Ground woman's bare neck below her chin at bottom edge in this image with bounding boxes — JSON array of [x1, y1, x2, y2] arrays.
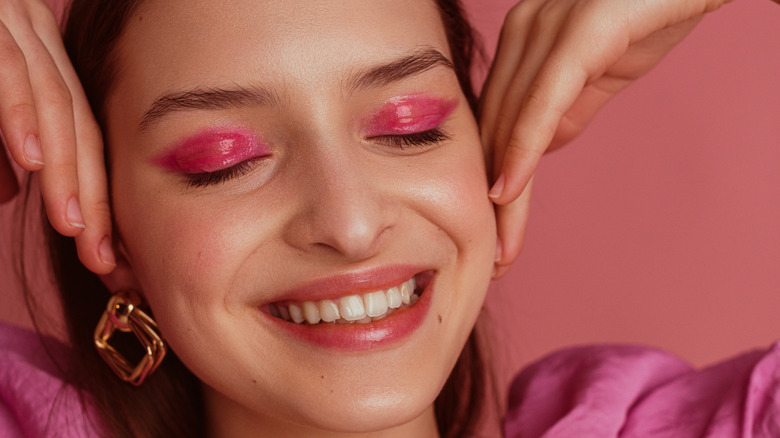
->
[[204, 385, 439, 438]]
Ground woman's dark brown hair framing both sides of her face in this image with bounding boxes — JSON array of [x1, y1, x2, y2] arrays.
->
[[30, 0, 492, 438]]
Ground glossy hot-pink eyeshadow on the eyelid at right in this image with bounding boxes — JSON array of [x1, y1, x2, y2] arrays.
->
[[367, 94, 458, 137]]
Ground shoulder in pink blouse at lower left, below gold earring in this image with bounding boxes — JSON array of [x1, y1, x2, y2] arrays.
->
[[0, 323, 104, 438]]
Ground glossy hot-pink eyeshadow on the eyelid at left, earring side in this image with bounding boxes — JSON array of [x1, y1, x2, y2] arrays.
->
[[154, 129, 269, 174]]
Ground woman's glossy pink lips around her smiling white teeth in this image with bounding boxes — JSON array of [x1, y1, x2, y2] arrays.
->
[[260, 267, 435, 351]]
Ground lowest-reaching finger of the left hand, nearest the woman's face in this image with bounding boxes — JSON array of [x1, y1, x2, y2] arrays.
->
[[32, 9, 116, 274]]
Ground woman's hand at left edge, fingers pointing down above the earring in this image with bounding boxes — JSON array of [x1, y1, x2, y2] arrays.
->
[[0, 0, 115, 274]]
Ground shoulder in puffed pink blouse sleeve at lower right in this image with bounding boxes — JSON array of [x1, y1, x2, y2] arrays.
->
[[504, 344, 780, 438]]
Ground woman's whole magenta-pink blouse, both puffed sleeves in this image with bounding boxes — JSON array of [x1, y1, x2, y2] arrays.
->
[[0, 323, 780, 438]]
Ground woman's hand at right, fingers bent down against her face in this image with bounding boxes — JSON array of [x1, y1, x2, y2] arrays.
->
[[480, 0, 729, 278]]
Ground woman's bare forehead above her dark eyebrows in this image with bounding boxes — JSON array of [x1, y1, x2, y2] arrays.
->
[[112, 0, 449, 114]]
